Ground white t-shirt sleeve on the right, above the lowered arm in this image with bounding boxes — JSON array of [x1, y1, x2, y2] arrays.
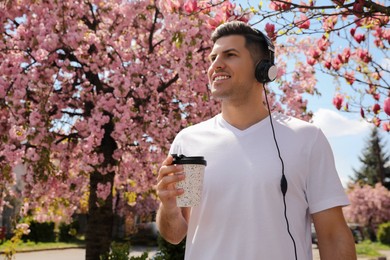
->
[[307, 129, 349, 214]]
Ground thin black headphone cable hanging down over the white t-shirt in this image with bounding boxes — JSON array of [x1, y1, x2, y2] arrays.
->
[[263, 83, 298, 260]]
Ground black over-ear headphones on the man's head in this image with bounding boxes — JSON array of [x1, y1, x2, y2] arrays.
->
[[253, 28, 278, 83]]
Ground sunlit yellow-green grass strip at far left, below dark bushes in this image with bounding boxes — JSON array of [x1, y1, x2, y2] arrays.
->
[[0, 241, 85, 252]]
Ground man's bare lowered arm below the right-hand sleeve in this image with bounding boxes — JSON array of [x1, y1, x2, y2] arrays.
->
[[312, 207, 357, 260]]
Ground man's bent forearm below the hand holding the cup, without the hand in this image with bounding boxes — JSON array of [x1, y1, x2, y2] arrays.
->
[[156, 204, 188, 244]]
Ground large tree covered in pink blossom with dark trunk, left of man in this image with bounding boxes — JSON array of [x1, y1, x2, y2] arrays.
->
[[0, 0, 253, 259]]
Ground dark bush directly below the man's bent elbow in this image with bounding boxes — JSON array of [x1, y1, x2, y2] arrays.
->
[[154, 235, 186, 260]]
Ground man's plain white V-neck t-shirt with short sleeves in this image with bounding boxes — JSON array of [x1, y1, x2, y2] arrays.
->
[[170, 113, 348, 260]]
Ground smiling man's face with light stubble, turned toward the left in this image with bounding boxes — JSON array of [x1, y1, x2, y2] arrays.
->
[[208, 35, 257, 100]]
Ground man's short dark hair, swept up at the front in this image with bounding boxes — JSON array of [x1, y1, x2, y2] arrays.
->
[[211, 21, 274, 64]]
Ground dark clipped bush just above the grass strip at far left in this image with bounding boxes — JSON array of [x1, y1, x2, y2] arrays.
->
[[22, 221, 56, 243]]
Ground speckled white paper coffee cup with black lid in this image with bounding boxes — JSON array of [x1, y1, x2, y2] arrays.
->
[[172, 154, 207, 207]]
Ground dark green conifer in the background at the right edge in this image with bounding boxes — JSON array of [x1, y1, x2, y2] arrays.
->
[[352, 128, 390, 189]]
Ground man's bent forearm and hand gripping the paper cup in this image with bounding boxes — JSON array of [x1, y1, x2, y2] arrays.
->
[[156, 156, 190, 244]]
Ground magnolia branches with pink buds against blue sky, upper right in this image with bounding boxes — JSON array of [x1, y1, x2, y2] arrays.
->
[[245, 0, 390, 131]]
